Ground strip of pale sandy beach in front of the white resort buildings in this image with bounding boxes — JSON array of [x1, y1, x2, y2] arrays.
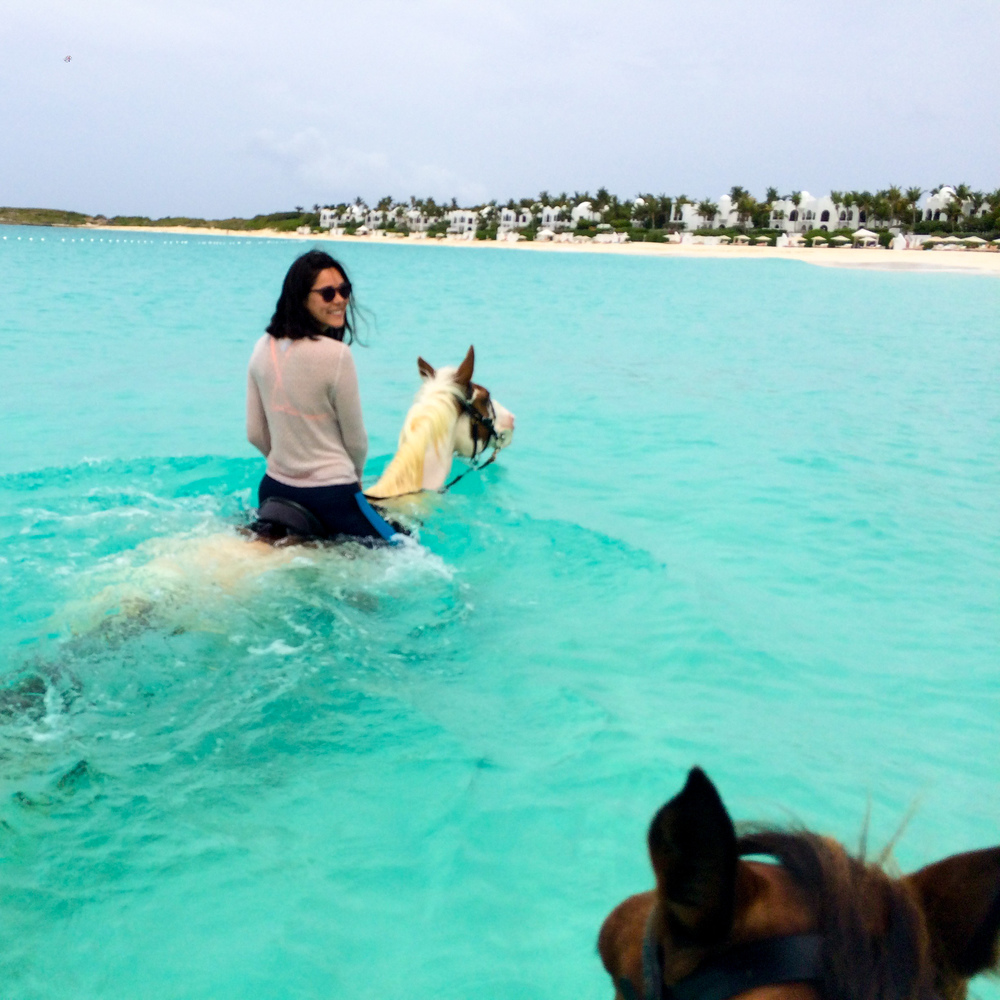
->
[[23, 225, 1000, 277]]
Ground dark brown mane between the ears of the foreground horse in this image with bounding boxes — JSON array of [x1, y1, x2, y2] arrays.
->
[[737, 828, 938, 1000]]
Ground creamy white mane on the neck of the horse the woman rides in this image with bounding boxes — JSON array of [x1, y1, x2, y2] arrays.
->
[[365, 367, 462, 498]]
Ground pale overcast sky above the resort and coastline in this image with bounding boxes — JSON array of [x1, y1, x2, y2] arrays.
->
[[0, 0, 1000, 217]]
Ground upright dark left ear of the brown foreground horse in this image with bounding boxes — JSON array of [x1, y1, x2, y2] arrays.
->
[[649, 767, 738, 947]]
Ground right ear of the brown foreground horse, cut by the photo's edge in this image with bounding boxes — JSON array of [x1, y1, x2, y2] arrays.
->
[[906, 847, 1000, 978]]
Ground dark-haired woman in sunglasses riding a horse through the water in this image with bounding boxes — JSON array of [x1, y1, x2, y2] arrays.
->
[[247, 250, 396, 540]]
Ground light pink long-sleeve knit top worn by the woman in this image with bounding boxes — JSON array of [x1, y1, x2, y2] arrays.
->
[[247, 333, 368, 486]]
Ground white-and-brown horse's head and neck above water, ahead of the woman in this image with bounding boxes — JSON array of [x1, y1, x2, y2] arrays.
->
[[365, 347, 514, 503]]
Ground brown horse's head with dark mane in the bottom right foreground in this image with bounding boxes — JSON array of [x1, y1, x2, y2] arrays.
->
[[598, 768, 1000, 1000]]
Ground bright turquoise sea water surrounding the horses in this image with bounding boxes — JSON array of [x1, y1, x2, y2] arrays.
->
[[0, 227, 1000, 1000]]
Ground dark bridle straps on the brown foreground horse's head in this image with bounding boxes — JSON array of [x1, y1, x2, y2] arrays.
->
[[618, 907, 823, 1000]]
